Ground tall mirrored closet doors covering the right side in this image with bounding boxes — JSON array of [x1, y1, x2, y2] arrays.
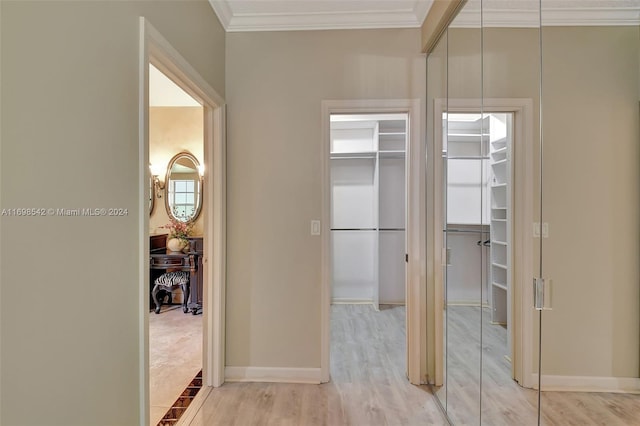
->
[[427, 0, 640, 424]]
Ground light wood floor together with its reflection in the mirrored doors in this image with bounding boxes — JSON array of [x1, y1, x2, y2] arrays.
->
[[181, 305, 640, 426]]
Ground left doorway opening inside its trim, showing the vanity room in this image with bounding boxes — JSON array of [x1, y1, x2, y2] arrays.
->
[[149, 64, 202, 425]]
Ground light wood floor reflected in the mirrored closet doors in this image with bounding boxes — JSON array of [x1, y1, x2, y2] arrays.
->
[[436, 306, 640, 426]]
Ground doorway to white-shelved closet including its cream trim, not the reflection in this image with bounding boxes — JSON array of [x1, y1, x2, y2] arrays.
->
[[321, 99, 426, 384]]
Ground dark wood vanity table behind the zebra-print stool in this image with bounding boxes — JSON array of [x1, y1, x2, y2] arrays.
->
[[149, 234, 203, 315]]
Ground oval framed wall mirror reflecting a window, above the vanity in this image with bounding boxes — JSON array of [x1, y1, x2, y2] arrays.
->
[[164, 152, 202, 222]]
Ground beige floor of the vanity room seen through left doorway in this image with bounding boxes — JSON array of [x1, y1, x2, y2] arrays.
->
[[149, 306, 202, 426]]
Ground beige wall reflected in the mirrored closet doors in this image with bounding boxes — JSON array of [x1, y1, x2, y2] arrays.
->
[[428, 27, 640, 377]]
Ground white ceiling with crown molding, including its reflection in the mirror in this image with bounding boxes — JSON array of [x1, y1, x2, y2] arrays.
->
[[209, 0, 640, 32]]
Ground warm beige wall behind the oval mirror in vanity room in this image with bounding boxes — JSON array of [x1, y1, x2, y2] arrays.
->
[[149, 107, 207, 235]]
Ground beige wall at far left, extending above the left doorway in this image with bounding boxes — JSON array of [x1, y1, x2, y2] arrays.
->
[[0, 0, 225, 426]]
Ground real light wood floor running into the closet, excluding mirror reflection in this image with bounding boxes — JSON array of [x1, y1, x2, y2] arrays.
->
[[185, 305, 447, 426]]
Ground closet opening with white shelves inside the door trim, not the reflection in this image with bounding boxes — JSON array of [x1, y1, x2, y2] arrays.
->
[[329, 113, 408, 382]]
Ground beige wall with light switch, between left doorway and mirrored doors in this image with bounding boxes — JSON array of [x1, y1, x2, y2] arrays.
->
[[226, 29, 425, 368]]
